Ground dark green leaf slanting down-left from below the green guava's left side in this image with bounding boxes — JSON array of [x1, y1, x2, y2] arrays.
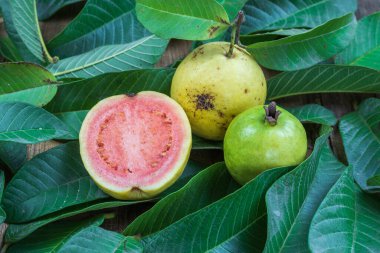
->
[[123, 163, 238, 236]]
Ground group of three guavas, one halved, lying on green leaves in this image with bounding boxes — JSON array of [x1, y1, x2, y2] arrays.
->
[[79, 37, 307, 200]]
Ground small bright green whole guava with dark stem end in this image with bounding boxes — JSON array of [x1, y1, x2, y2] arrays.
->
[[224, 102, 307, 185]]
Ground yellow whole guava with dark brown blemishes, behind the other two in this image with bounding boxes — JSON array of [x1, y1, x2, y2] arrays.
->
[[171, 42, 267, 140]]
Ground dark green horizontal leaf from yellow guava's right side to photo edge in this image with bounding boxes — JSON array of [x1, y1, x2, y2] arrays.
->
[[268, 65, 380, 100]]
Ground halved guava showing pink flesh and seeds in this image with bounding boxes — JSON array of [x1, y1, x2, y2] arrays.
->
[[79, 91, 192, 200]]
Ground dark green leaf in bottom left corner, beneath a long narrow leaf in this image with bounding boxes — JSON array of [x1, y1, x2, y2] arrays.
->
[[7, 216, 104, 253]]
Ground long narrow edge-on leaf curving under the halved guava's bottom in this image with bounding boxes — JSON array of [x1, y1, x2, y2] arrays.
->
[[5, 160, 204, 243]]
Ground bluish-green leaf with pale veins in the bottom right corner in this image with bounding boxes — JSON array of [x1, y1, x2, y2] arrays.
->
[[309, 168, 380, 252]]
